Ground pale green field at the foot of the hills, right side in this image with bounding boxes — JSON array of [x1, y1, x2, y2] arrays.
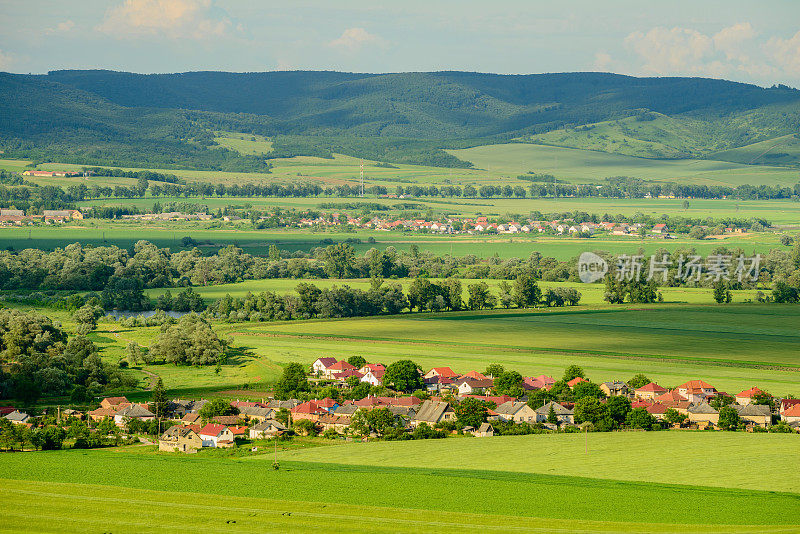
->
[[447, 143, 798, 186]]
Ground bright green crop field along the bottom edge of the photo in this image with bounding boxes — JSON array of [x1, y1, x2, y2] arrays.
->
[[0, 448, 800, 532]]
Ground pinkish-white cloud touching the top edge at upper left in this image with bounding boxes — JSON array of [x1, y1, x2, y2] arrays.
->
[[97, 0, 233, 39]]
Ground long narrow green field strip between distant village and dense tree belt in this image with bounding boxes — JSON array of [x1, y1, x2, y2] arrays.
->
[[0, 221, 789, 260]]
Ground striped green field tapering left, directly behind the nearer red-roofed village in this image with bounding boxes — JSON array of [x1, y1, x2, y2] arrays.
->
[[220, 304, 800, 395]]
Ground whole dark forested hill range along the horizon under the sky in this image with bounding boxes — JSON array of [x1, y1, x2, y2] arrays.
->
[[0, 70, 800, 170]]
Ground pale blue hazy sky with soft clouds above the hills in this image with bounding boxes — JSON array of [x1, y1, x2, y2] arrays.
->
[[0, 0, 800, 87]]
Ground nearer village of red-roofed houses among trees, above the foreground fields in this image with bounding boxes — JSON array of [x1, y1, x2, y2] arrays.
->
[[0, 357, 800, 453]]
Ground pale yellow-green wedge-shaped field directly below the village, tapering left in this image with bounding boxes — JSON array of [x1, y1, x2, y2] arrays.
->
[[278, 430, 800, 494]]
